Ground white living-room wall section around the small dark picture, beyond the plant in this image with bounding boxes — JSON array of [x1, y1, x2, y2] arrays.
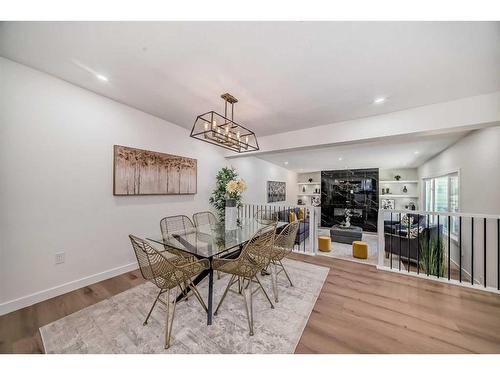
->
[[228, 156, 297, 204]]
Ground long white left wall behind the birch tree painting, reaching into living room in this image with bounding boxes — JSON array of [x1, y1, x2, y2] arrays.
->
[[0, 58, 296, 315]]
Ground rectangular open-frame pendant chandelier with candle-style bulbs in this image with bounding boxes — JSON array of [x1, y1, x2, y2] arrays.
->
[[191, 93, 259, 152]]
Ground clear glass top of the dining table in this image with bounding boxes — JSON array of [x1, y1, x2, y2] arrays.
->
[[146, 219, 287, 258]]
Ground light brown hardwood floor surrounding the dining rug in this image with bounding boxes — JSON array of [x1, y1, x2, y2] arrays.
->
[[0, 254, 500, 353]]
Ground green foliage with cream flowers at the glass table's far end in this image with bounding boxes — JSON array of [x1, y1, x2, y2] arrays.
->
[[209, 167, 246, 221]]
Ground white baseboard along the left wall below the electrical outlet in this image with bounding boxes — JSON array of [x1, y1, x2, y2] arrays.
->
[[0, 262, 137, 316]]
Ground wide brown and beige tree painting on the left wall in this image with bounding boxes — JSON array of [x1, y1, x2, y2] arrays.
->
[[113, 145, 197, 195]]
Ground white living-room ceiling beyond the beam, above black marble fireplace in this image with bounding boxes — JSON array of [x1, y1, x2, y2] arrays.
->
[[258, 132, 468, 173]]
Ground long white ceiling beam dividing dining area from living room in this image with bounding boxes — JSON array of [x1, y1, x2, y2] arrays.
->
[[248, 91, 500, 154]]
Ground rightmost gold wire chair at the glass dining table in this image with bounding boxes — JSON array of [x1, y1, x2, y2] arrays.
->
[[270, 220, 300, 302]]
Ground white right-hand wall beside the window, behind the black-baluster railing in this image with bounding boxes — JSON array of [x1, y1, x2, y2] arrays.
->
[[418, 126, 500, 287]]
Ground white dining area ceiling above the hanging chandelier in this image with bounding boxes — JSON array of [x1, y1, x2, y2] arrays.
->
[[0, 22, 500, 136]]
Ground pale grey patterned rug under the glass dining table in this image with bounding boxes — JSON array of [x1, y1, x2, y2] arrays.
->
[[40, 259, 329, 353]]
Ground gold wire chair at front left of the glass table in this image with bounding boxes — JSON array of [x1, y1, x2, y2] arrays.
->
[[129, 235, 210, 349]]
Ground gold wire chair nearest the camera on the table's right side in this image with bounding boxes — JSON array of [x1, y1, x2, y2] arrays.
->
[[212, 223, 276, 336]]
